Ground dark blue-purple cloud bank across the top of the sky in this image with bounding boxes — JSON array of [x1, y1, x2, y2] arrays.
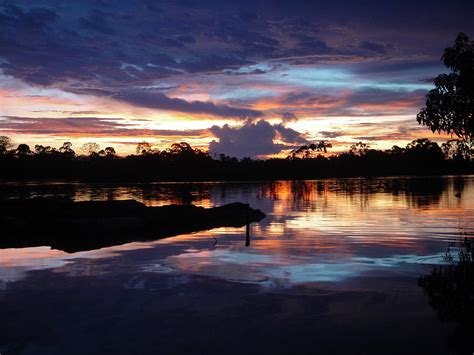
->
[[0, 0, 473, 84]]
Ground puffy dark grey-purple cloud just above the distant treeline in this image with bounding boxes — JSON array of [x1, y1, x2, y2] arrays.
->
[[209, 120, 307, 158]]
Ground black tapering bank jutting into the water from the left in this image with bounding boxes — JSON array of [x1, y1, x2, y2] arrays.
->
[[0, 198, 265, 252]]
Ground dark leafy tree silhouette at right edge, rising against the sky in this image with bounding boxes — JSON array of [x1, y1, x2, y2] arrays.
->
[[416, 33, 474, 142]]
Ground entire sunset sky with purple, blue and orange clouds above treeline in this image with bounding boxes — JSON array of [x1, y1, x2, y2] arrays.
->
[[0, 0, 474, 158]]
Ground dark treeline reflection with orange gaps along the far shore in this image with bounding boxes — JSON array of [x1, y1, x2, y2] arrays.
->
[[0, 176, 462, 210]]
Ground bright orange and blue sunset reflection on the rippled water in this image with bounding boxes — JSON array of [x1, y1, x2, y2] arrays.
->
[[0, 177, 474, 287]]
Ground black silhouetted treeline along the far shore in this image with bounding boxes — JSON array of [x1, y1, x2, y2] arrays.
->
[[0, 137, 474, 181]]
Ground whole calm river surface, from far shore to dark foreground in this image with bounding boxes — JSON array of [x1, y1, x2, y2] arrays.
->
[[0, 177, 474, 355]]
